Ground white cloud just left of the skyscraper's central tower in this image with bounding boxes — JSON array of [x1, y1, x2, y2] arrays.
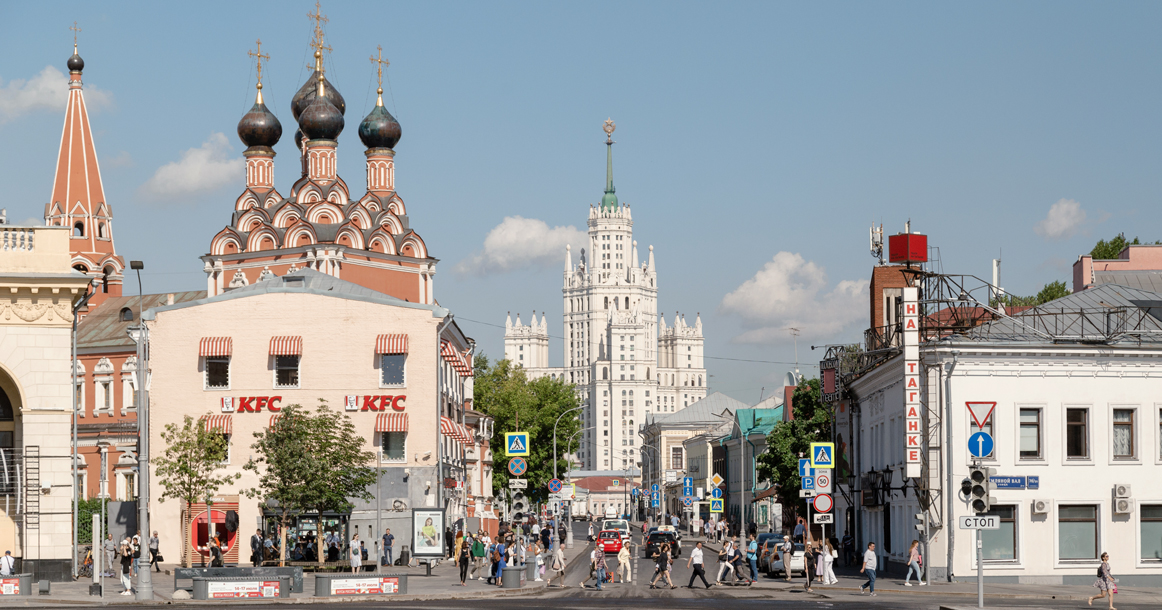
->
[[456, 216, 586, 274]]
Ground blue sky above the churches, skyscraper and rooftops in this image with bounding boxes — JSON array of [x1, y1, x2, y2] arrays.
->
[[0, 1, 1162, 402]]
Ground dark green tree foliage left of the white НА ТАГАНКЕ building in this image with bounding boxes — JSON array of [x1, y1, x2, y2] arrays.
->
[[758, 379, 831, 517]]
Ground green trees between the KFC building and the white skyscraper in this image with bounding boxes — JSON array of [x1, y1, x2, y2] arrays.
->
[[473, 356, 581, 502]]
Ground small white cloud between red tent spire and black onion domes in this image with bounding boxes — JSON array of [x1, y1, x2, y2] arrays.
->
[[141, 132, 246, 201]]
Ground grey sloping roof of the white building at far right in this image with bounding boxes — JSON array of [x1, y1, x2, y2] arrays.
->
[[949, 284, 1162, 345]]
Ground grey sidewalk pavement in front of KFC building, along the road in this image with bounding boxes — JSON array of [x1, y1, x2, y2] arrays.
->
[[5, 540, 588, 607]]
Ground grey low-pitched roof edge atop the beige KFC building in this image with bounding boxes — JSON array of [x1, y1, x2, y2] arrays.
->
[[144, 268, 449, 320]]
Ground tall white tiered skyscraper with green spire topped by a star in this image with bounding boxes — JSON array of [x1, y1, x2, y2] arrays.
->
[[504, 121, 706, 471]]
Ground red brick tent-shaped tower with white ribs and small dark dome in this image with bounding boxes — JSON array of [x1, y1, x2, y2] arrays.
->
[[44, 38, 125, 310]]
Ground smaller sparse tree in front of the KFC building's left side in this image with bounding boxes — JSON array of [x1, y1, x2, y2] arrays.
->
[[153, 415, 242, 565]]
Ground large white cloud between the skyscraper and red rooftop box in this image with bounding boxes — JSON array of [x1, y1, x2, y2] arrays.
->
[[719, 252, 868, 343]]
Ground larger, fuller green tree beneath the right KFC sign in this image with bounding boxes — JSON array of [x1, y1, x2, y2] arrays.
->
[[243, 400, 376, 564]]
